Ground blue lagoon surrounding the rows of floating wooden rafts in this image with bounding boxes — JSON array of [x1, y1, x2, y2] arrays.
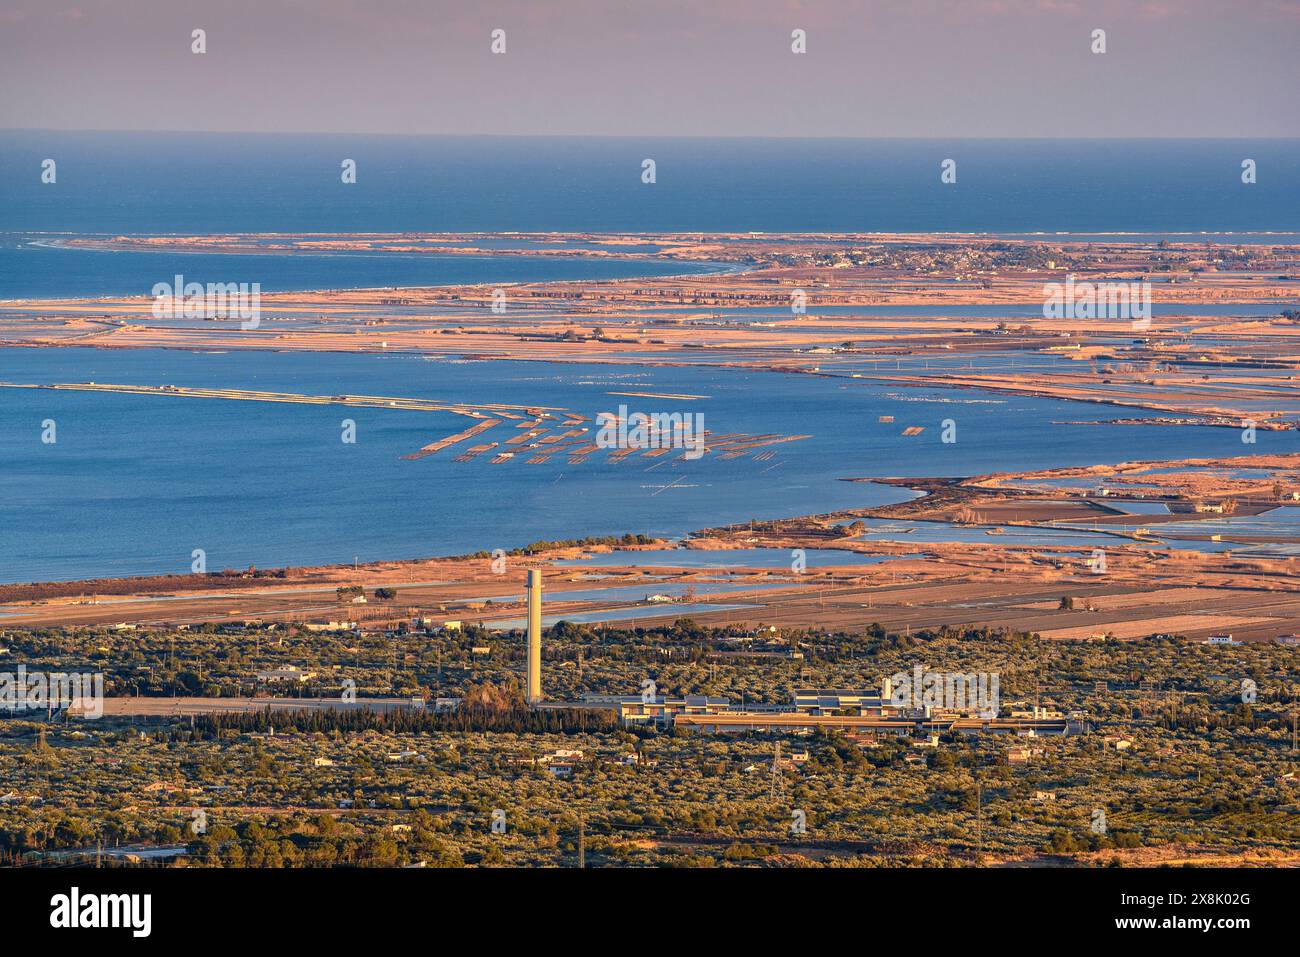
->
[[0, 348, 1297, 581]]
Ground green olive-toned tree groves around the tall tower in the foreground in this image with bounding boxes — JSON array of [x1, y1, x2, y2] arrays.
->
[[0, 619, 1300, 867]]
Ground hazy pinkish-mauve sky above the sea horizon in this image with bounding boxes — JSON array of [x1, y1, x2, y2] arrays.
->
[[0, 0, 1300, 137]]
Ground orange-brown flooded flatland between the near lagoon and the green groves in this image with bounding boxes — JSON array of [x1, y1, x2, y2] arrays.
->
[[10, 452, 1300, 641]]
